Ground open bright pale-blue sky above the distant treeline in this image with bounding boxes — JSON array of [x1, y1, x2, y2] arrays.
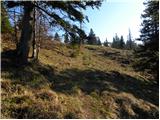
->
[[84, 0, 145, 42]]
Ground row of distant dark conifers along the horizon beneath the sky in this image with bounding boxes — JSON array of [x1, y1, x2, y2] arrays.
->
[[52, 29, 138, 50]]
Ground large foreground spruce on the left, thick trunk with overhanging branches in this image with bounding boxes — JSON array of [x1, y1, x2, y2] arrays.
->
[[5, 1, 102, 65]]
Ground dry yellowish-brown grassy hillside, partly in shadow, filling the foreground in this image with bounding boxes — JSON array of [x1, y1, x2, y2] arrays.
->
[[1, 39, 159, 118]]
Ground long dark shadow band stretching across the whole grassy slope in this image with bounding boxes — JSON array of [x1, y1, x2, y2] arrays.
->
[[1, 49, 159, 105]]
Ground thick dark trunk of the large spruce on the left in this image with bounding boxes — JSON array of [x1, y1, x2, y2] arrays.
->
[[18, 2, 33, 64]]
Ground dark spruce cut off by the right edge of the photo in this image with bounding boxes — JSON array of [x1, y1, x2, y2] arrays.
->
[[135, 1, 159, 81]]
